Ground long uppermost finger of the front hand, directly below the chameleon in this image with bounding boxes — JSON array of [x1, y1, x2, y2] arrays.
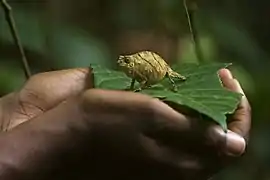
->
[[82, 89, 192, 132]]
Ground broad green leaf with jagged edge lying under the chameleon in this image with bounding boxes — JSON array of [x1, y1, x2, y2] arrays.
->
[[92, 63, 241, 130]]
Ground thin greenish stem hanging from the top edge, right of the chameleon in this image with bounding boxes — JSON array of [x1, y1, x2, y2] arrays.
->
[[183, 0, 203, 62]]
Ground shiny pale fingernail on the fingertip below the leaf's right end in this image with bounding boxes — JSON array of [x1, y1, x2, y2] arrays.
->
[[225, 130, 246, 156]]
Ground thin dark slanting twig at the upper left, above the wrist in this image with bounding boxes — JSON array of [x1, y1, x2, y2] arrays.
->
[[1, 0, 31, 79]]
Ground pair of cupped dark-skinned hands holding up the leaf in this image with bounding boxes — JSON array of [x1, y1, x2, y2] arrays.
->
[[0, 69, 251, 180]]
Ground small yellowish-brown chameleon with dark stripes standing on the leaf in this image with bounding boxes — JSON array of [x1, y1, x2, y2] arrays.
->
[[117, 51, 186, 91]]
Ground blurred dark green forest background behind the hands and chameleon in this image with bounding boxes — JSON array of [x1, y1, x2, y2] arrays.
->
[[0, 0, 270, 180]]
